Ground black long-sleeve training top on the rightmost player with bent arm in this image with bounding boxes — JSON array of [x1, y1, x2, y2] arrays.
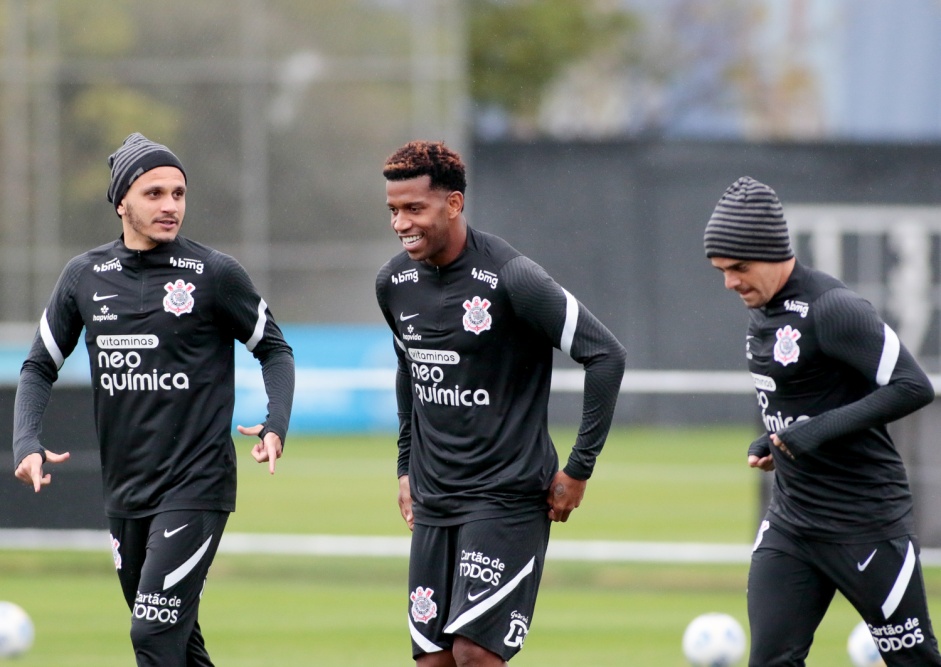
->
[[745, 262, 934, 543]]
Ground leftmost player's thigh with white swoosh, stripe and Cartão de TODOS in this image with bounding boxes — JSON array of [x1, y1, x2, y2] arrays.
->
[[132, 510, 228, 629]]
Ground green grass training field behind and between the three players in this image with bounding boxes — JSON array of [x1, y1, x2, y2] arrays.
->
[[0, 429, 928, 667]]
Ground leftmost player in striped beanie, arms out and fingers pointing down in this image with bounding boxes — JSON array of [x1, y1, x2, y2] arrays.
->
[[13, 133, 294, 667]]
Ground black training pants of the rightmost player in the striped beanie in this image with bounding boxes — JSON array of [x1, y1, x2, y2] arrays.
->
[[748, 517, 941, 667]]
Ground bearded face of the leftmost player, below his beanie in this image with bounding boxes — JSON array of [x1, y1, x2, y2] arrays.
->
[[117, 167, 186, 250]]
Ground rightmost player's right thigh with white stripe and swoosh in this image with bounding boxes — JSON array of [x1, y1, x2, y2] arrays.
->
[[827, 536, 941, 667]]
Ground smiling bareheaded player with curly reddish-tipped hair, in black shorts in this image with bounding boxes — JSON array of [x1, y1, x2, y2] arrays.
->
[[376, 141, 625, 667]]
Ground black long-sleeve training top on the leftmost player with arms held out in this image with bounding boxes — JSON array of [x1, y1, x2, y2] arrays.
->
[[13, 237, 294, 518]]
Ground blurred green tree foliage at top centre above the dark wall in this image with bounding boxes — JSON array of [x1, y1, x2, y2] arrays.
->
[[468, 0, 639, 119]]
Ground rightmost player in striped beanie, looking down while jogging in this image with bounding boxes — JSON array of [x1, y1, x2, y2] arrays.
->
[[705, 177, 941, 667]]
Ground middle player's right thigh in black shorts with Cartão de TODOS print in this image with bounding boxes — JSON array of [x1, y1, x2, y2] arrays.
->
[[445, 511, 551, 660]]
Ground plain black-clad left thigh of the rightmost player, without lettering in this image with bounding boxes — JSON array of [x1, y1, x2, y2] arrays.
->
[[747, 531, 836, 667]]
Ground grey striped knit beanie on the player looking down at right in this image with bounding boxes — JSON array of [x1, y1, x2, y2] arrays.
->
[[704, 176, 794, 262]]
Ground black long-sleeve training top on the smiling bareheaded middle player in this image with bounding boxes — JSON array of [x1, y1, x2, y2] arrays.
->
[[376, 228, 625, 525]]
